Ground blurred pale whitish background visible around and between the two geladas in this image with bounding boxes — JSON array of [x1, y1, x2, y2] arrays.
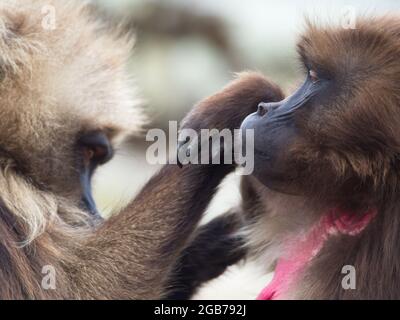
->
[[88, 0, 400, 298]]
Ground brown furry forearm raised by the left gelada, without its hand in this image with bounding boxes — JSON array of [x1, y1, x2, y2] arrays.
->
[[74, 165, 234, 299]]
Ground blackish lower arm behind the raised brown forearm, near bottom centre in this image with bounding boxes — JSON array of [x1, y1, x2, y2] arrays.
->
[[167, 210, 247, 300]]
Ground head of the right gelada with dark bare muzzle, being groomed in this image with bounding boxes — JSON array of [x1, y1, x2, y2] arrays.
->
[[242, 18, 400, 200]]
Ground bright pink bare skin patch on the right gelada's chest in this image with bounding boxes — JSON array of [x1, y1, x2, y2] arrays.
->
[[257, 209, 376, 300]]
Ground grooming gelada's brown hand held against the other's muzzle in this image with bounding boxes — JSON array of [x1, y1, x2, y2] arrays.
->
[[178, 72, 283, 165]]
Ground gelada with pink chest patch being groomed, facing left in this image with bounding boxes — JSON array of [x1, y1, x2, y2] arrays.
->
[[174, 16, 400, 299]]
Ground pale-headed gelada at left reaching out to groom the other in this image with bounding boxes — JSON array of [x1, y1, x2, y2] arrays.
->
[[0, 0, 278, 299]]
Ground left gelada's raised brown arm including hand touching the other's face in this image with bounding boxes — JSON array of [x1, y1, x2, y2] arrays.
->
[[70, 73, 283, 299]]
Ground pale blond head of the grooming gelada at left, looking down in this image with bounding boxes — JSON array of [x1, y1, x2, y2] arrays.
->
[[0, 0, 141, 211]]
